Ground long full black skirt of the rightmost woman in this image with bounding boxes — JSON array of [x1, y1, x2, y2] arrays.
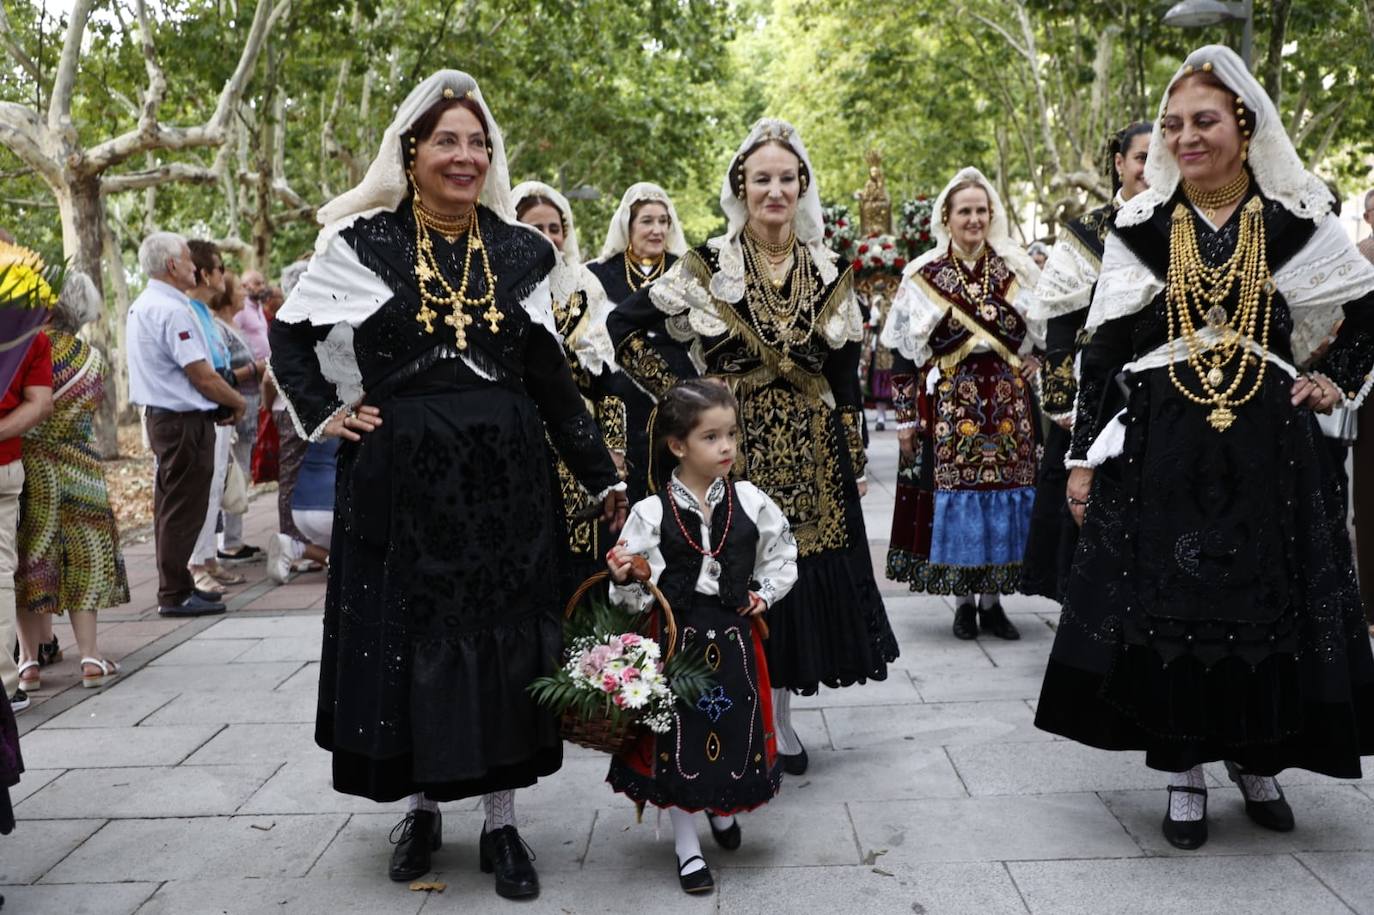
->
[[1036, 367, 1374, 778]]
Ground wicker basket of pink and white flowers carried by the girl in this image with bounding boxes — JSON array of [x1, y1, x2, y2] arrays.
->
[[529, 573, 713, 753]]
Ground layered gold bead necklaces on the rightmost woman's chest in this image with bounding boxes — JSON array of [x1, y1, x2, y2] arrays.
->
[[1165, 196, 1274, 431]]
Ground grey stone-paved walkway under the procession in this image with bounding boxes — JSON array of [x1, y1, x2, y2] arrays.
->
[[0, 431, 1374, 915]]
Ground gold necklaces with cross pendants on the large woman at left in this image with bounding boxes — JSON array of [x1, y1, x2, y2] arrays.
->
[[412, 190, 506, 349]]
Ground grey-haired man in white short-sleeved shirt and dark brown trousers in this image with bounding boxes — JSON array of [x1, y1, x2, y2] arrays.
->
[[126, 232, 246, 617]]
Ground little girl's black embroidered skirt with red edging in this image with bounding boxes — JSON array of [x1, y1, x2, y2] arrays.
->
[[606, 595, 782, 813]]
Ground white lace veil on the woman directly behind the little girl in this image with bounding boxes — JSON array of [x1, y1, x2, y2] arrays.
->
[[709, 118, 840, 302]]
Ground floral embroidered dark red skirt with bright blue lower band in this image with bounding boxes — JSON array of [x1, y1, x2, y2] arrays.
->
[[888, 353, 1036, 595]]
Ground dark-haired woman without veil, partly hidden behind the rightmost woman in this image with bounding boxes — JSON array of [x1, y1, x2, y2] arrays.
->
[[1021, 121, 1151, 600]]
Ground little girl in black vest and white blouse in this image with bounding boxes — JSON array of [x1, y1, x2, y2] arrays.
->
[[606, 378, 797, 893]]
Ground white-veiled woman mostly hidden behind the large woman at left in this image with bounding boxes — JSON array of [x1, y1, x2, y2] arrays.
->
[[511, 181, 627, 598]]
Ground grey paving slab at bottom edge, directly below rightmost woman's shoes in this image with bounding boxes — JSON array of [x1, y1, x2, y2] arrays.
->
[[1007, 855, 1349, 915]]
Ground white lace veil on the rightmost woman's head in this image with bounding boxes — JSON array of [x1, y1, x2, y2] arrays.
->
[[1117, 44, 1331, 227]]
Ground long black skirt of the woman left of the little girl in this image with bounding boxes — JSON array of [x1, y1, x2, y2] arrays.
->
[[315, 376, 562, 801]]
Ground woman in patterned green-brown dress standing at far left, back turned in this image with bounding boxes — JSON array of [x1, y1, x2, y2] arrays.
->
[[15, 273, 129, 694]]
